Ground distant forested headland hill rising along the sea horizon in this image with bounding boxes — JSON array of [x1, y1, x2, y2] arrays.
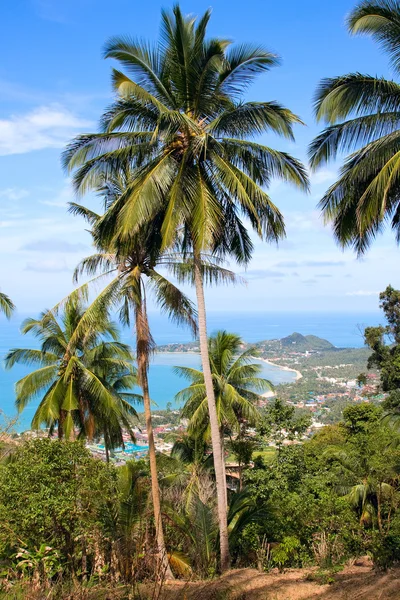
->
[[157, 332, 336, 353]]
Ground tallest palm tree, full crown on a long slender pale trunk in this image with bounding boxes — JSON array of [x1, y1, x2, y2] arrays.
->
[[64, 6, 308, 570]]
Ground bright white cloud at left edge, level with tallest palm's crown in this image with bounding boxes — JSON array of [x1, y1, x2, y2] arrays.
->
[[0, 104, 92, 156]]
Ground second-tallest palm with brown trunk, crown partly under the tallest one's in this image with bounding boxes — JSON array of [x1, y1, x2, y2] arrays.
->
[[64, 168, 202, 578]]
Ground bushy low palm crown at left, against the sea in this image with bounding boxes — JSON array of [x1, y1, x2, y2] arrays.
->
[[5, 300, 141, 458]]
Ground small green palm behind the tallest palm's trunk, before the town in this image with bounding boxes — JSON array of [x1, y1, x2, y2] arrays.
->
[[175, 331, 272, 500]]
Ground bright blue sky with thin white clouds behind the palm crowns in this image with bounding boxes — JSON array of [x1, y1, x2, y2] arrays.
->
[[0, 0, 400, 314]]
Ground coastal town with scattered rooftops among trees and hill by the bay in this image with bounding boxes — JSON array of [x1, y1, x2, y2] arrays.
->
[[75, 333, 386, 468]]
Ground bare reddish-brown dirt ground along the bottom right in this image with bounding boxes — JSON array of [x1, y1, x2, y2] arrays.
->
[[148, 559, 400, 600]]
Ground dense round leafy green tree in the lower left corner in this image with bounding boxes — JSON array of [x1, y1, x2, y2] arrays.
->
[[0, 438, 116, 574]]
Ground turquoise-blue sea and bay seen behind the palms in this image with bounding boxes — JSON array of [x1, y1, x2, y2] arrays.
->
[[0, 311, 382, 431]]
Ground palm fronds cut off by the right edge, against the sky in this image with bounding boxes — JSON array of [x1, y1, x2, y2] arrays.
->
[[310, 0, 400, 254]]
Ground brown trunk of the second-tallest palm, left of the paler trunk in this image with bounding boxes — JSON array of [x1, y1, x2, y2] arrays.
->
[[135, 303, 173, 579]]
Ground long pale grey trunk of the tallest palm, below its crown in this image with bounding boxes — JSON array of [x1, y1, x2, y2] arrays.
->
[[194, 253, 230, 573]]
